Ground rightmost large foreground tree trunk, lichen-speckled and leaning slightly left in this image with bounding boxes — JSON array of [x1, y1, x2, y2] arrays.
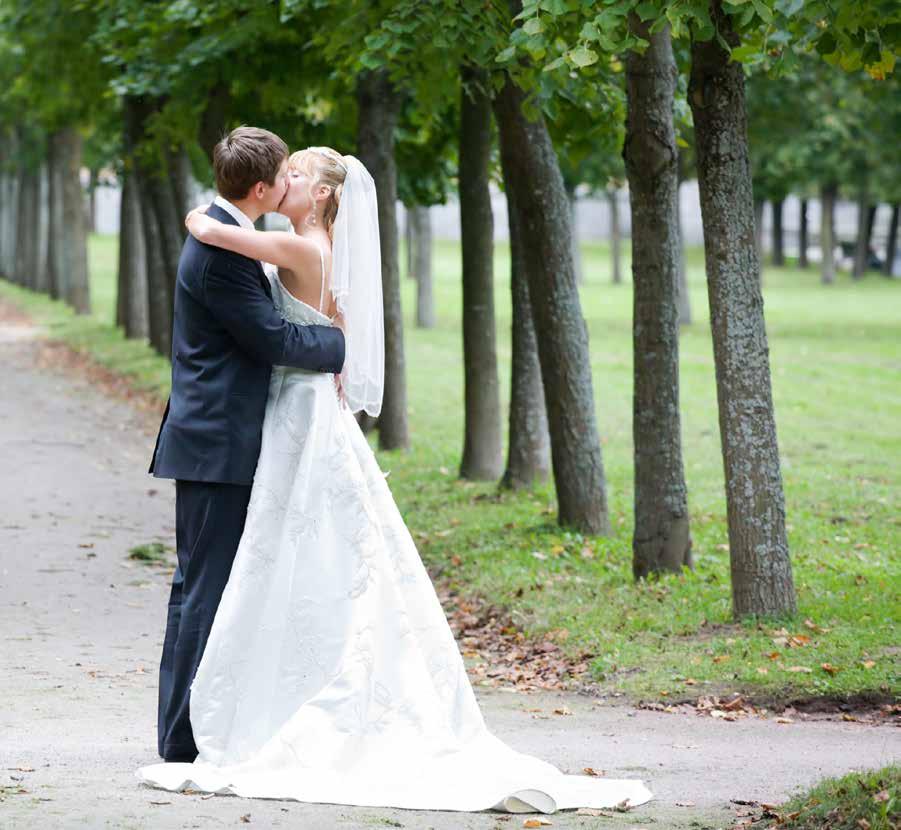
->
[[689, 0, 796, 617]]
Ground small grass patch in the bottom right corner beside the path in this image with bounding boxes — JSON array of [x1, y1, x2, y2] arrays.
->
[[771, 765, 901, 830]]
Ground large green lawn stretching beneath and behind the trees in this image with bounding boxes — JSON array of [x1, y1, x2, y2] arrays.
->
[[0, 237, 901, 699]]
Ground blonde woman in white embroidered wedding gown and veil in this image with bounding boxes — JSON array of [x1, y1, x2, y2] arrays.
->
[[136, 147, 653, 813]]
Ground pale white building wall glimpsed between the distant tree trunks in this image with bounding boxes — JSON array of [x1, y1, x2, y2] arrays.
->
[[96, 181, 901, 274]]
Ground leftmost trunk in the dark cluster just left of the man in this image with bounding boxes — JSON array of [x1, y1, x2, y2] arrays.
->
[[116, 166, 150, 339]]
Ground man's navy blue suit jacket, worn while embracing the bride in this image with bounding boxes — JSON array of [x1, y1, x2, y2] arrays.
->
[[150, 205, 344, 484]]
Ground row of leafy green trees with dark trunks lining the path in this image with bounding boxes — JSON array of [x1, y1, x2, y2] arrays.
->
[[0, 0, 899, 615]]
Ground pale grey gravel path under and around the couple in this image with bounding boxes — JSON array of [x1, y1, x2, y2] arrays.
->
[[0, 307, 901, 830]]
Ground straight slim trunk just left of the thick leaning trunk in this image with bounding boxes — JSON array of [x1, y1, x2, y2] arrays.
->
[[459, 66, 504, 481]]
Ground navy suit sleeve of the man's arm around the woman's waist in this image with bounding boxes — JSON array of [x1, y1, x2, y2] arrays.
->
[[203, 252, 344, 374]]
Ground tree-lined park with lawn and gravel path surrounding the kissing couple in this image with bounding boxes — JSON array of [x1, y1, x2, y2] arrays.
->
[[0, 0, 901, 830]]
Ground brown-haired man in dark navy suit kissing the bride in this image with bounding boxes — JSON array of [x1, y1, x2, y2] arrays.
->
[[150, 127, 344, 761]]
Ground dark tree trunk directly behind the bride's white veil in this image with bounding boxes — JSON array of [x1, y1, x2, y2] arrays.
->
[[357, 70, 410, 450]]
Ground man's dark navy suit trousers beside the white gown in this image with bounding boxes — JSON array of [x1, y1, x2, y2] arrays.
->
[[157, 480, 251, 761]]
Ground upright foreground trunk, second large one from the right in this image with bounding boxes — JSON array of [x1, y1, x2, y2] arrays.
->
[[623, 14, 691, 579]]
